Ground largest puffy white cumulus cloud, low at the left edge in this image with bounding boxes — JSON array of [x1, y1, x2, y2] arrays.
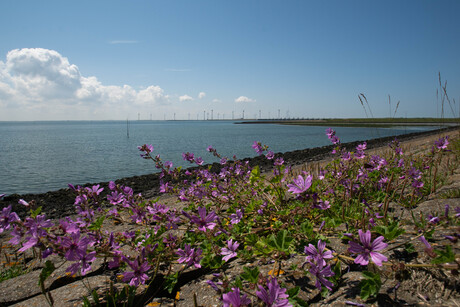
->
[[0, 48, 169, 119]]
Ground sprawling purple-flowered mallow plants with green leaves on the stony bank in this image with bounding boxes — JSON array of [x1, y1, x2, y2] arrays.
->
[[0, 129, 460, 306]]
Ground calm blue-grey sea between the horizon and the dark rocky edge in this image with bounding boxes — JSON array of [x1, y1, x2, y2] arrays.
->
[[0, 121, 433, 194]]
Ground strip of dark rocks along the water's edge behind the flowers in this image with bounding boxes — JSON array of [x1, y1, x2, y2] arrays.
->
[[0, 127, 458, 219]]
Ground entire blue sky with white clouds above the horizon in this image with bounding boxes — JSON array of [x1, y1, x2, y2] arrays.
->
[[0, 0, 460, 121]]
